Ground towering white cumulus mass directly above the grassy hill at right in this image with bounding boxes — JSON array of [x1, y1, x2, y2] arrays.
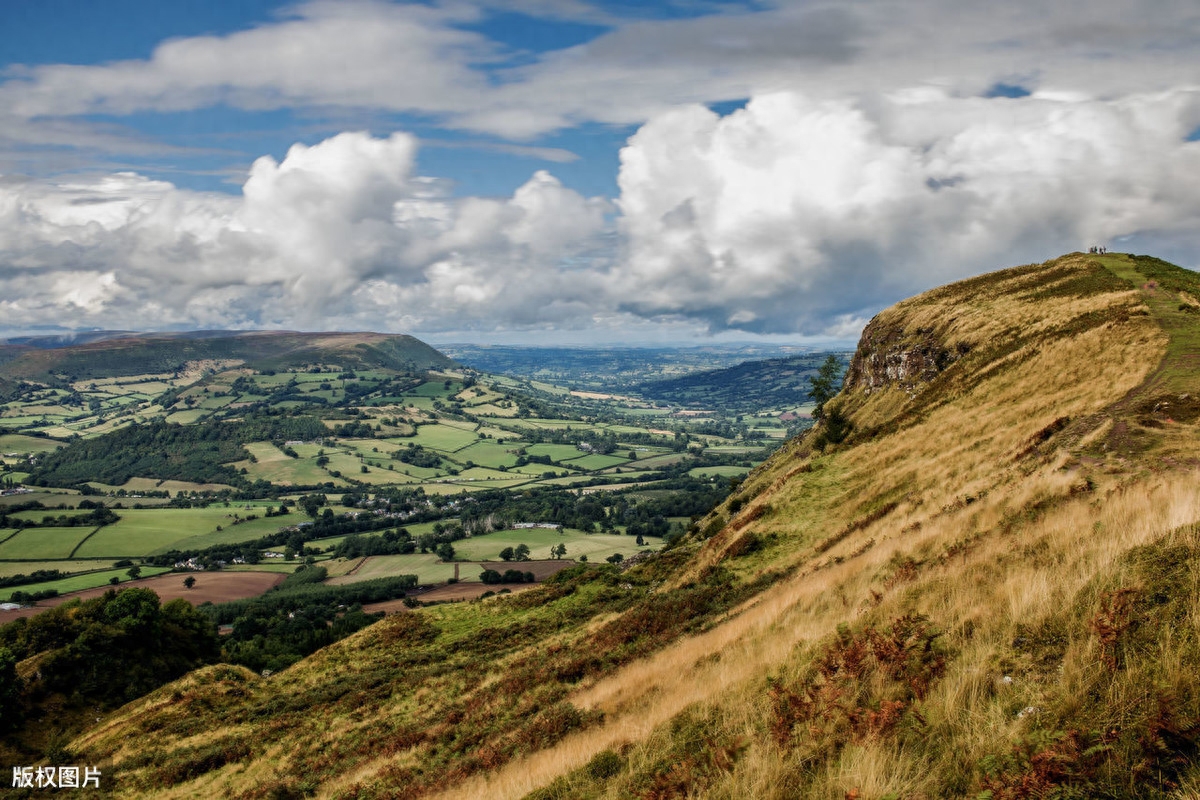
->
[[610, 89, 1200, 335]]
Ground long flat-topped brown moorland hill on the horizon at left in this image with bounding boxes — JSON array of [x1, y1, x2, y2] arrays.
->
[[0, 331, 455, 387]]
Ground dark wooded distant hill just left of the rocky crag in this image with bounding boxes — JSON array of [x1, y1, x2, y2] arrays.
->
[[630, 353, 851, 411]]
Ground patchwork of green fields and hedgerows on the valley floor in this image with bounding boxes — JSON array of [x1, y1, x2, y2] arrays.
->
[[0, 333, 806, 633]]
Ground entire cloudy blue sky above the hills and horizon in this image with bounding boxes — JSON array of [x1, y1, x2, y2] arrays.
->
[[0, 0, 1200, 345]]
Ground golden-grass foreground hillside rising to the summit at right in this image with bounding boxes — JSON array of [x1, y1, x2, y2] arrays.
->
[[68, 254, 1200, 800]]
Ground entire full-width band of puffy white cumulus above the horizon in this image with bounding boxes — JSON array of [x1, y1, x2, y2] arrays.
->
[[0, 86, 1200, 339]]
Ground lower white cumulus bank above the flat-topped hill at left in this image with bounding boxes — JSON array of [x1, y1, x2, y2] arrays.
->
[[0, 133, 610, 330]]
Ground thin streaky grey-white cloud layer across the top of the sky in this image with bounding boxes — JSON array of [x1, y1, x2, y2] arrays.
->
[[0, 0, 1200, 148]]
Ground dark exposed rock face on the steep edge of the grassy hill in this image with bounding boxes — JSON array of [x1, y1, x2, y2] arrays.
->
[[845, 315, 966, 395]]
